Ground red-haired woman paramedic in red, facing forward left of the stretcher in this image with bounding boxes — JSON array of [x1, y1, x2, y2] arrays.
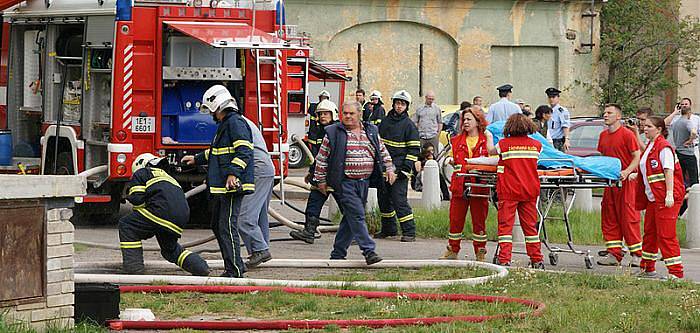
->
[[440, 108, 489, 261]]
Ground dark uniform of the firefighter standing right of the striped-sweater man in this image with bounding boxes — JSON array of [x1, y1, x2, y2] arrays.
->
[[375, 104, 420, 240]]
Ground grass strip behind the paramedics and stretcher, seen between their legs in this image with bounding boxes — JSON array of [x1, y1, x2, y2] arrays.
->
[[408, 207, 686, 246]]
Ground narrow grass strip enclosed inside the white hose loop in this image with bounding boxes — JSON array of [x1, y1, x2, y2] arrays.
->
[[314, 266, 492, 281]]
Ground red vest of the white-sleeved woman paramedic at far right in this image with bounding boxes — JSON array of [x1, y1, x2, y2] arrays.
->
[[635, 136, 685, 210]]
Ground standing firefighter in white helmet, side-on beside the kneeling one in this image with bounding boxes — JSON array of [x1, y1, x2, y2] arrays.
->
[[182, 85, 255, 278]]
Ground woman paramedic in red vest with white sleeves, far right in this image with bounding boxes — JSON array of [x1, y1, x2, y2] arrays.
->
[[637, 117, 685, 279]]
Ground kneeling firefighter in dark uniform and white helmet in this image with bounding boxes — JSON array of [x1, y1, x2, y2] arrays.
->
[[119, 153, 209, 276]]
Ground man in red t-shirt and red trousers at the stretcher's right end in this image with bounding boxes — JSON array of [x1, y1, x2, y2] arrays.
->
[[598, 104, 642, 267]]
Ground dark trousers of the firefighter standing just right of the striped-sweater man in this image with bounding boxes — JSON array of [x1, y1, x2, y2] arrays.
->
[[378, 176, 416, 236]]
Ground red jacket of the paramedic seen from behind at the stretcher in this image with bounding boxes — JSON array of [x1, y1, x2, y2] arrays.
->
[[496, 136, 542, 201]]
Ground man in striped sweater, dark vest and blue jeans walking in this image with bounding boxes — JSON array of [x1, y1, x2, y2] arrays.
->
[[314, 101, 396, 265]]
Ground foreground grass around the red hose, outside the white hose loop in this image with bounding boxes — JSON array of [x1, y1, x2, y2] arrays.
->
[[121, 270, 700, 333]]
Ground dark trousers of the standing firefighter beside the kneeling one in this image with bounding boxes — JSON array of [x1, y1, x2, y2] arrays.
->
[[210, 194, 245, 277]]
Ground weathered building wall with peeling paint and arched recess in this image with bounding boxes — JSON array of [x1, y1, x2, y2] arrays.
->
[[286, 0, 600, 115]]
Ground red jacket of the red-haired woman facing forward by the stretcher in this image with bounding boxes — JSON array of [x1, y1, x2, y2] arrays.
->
[[450, 132, 489, 198]]
